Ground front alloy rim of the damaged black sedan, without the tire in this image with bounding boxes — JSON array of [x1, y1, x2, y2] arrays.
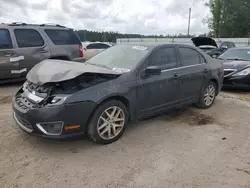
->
[[97, 106, 125, 140]]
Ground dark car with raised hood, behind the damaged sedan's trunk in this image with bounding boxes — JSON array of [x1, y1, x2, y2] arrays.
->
[[191, 37, 235, 58]]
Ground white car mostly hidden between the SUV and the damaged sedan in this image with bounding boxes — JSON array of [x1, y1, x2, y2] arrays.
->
[[84, 42, 111, 60]]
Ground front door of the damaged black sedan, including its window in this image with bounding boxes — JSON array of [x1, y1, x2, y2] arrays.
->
[[137, 47, 179, 117]]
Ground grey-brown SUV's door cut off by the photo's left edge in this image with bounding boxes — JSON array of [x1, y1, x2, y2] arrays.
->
[[0, 28, 19, 79]]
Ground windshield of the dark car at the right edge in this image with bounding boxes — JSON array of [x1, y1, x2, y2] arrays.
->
[[218, 48, 250, 61]]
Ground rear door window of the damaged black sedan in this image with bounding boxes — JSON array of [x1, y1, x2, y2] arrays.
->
[[179, 47, 201, 66]]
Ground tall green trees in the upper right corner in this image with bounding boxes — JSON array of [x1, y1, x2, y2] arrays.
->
[[205, 0, 250, 38]]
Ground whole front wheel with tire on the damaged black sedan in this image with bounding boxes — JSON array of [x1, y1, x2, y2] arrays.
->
[[88, 100, 129, 144]]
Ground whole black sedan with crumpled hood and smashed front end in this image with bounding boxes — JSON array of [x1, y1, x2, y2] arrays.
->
[[13, 44, 223, 144]]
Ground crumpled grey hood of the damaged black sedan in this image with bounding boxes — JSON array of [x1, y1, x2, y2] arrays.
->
[[26, 59, 121, 85]]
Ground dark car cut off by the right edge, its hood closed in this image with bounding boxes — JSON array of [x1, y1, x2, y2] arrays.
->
[[218, 47, 250, 89]]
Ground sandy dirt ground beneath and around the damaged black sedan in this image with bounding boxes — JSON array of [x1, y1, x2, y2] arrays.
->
[[0, 85, 250, 188]]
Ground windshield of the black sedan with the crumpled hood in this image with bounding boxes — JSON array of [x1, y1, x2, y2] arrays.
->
[[86, 45, 149, 71]]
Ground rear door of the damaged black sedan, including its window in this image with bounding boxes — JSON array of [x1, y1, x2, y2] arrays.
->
[[178, 47, 211, 103]]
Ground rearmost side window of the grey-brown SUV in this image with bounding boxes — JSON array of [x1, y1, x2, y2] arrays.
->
[[45, 29, 80, 45]]
